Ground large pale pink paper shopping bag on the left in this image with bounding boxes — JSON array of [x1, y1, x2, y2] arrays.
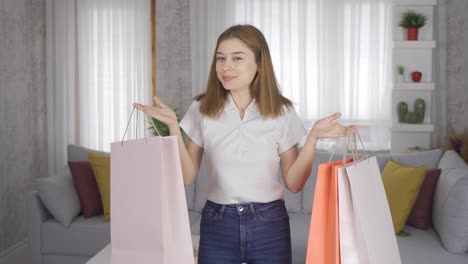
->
[[111, 136, 194, 264]]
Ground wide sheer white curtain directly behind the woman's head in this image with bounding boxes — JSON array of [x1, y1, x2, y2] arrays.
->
[[190, 0, 392, 150]]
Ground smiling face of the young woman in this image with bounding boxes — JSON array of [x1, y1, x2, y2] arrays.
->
[[216, 38, 258, 92]]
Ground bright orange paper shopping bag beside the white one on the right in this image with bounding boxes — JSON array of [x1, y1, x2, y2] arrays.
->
[[306, 159, 353, 264]]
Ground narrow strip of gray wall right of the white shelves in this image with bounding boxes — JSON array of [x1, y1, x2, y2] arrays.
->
[[446, 0, 468, 133]]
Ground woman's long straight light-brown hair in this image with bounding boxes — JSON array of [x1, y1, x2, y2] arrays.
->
[[194, 25, 292, 118]]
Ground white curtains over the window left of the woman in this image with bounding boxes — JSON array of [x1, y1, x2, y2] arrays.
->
[[47, 0, 151, 173]]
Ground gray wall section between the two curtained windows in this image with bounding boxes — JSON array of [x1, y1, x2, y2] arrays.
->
[[156, 0, 192, 117]]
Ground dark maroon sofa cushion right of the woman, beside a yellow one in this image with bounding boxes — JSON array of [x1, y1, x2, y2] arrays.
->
[[406, 169, 441, 230]]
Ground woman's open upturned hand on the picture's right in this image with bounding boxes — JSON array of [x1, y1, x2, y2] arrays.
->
[[309, 113, 357, 140]]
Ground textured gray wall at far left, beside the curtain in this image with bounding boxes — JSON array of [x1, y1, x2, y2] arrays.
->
[[0, 0, 47, 252]]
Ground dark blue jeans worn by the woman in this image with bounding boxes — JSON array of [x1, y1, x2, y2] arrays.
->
[[198, 199, 291, 264]]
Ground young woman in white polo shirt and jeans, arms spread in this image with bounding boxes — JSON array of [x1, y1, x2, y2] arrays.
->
[[134, 25, 355, 264]]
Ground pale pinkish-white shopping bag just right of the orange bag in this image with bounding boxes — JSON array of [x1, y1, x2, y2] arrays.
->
[[338, 157, 401, 264]]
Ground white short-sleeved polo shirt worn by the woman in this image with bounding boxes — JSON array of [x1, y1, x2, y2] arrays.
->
[[180, 96, 306, 204]]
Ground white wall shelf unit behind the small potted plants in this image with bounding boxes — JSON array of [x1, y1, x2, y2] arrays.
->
[[390, 0, 437, 153]]
